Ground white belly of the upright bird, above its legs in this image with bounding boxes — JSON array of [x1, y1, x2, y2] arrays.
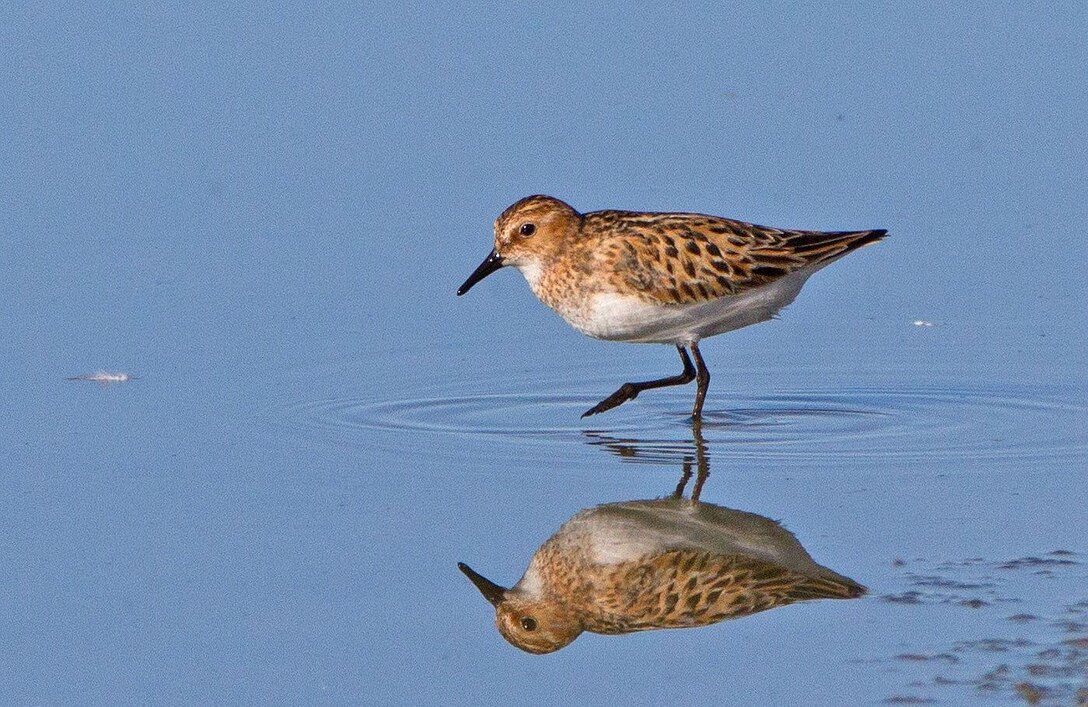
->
[[560, 270, 813, 344]]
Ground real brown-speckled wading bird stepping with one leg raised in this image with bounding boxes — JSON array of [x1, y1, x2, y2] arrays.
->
[[457, 196, 887, 419]]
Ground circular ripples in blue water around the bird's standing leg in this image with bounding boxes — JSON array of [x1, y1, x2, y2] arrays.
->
[[269, 382, 1088, 463]]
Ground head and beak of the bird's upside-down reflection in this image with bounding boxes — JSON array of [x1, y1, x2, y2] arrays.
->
[[458, 563, 584, 654]]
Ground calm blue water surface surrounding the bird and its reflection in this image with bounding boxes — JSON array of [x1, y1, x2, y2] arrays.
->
[[0, 2, 1088, 705]]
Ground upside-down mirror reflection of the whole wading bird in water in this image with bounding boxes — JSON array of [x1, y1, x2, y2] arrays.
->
[[458, 415, 865, 653]]
